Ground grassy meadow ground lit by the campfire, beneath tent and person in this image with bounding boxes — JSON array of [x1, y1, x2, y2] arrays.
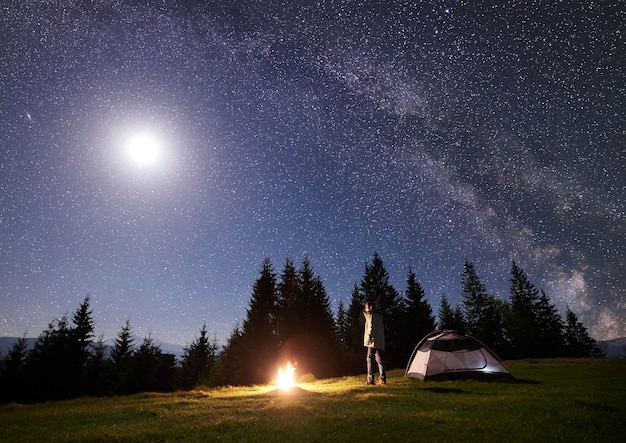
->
[[0, 358, 626, 442]]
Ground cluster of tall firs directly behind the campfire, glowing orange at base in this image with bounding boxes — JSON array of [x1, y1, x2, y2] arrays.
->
[[219, 258, 340, 384]]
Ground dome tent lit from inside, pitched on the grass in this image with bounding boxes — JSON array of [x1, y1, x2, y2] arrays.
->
[[404, 330, 513, 380]]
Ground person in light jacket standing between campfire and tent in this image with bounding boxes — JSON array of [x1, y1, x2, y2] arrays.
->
[[363, 301, 387, 385]]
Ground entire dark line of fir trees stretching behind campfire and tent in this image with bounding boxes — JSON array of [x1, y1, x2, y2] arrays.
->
[[0, 253, 598, 402]]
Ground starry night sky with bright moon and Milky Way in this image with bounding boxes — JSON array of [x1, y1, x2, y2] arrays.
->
[[0, 0, 626, 345]]
